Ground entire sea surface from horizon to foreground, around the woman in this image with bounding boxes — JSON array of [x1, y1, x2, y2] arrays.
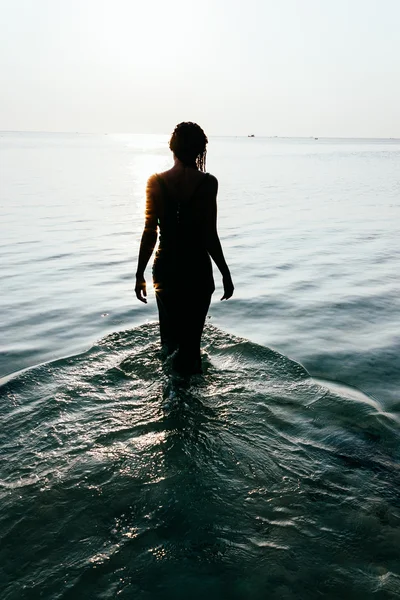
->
[[0, 132, 400, 600]]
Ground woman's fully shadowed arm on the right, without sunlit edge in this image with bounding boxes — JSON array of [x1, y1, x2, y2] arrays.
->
[[205, 175, 234, 300]]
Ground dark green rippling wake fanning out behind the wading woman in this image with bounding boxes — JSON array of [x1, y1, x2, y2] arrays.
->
[[0, 324, 400, 600]]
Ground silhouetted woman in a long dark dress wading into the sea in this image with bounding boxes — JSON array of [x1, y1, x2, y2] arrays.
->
[[135, 122, 234, 374]]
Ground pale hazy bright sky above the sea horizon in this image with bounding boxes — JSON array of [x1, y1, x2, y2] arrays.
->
[[0, 0, 400, 137]]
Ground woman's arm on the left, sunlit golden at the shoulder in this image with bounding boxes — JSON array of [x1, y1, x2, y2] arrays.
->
[[135, 175, 158, 303]]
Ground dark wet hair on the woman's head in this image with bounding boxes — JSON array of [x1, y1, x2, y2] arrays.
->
[[169, 121, 208, 171]]
